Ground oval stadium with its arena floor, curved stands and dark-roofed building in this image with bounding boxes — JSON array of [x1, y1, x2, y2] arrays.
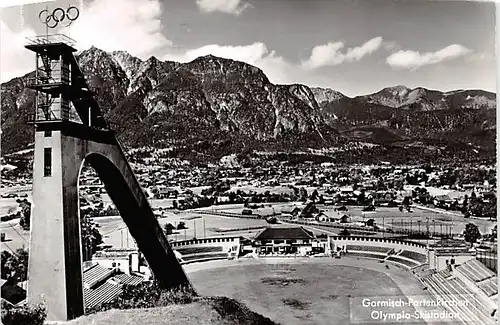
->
[[154, 225, 498, 324]]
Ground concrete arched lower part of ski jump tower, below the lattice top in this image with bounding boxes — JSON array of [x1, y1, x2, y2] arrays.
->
[[28, 123, 191, 320]]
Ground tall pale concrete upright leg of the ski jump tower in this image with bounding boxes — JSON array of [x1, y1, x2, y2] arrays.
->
[[28, 131, 83, 320]]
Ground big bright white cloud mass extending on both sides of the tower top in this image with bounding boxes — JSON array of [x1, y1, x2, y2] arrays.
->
[[0, 0, 172, 82]]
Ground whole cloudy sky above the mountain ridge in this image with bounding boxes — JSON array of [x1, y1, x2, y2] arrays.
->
[[0, 0, 496, 96]]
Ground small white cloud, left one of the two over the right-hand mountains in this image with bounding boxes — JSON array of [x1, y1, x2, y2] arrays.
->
[[302, 37, 383, 69]]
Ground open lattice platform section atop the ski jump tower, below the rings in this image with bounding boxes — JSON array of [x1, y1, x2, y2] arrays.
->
[[25, 34, 110, 130]]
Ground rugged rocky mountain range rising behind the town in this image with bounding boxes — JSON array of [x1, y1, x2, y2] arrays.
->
[[1, 47, 496, 160]]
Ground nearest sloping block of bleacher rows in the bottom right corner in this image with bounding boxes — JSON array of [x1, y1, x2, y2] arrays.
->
[[422, 272, 495, 325]]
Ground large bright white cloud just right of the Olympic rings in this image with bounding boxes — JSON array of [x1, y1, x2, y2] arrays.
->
[[69, 0, 172, 58]]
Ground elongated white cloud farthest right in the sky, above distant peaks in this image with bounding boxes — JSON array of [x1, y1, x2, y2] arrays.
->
[[386, 44, 472, 70]]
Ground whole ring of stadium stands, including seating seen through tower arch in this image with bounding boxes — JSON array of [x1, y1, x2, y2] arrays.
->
[[74, 226, 498, 325]]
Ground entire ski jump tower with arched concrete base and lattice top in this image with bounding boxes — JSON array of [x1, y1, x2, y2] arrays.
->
[[25, 7, 190, 321]]
